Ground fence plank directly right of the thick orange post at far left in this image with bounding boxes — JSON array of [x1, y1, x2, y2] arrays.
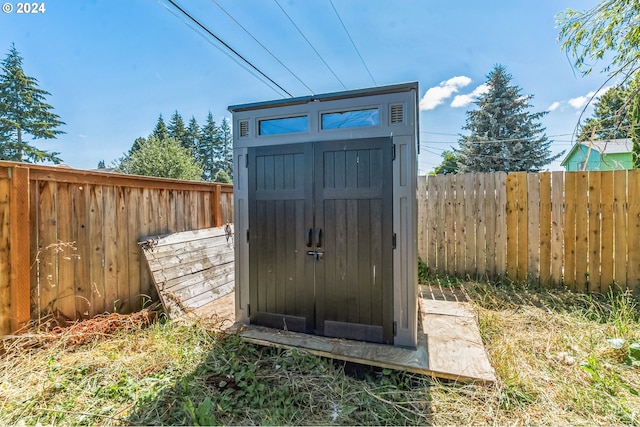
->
[[36, 181, 59, 315]]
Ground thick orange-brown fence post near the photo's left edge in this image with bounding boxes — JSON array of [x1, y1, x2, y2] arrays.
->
[[9, 166, 31, 331]]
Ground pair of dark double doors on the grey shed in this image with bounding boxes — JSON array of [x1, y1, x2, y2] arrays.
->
[[248, 138, 393, 344]]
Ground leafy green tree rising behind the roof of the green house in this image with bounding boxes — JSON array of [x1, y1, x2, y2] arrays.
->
[[578, 85, 631, 141]]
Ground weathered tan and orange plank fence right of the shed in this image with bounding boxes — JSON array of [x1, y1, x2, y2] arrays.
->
[[418, 170, 640, 294]]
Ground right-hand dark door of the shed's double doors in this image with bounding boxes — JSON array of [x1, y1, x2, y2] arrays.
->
[[314, 138, 393, 343]]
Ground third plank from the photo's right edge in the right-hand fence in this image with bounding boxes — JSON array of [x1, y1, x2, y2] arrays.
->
[[600, 171, 614, 292]]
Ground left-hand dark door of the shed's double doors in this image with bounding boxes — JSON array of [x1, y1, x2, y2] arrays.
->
[[248, 144, 314, 332]]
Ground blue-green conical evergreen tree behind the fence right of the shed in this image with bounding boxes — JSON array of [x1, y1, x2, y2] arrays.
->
[[454, 65, 563, 172]]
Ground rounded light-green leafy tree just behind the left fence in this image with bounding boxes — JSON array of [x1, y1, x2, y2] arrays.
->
[[118, 135, 202, 181]]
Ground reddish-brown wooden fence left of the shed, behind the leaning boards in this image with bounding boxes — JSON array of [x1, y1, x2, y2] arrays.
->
[[0, 162, 233, 334]]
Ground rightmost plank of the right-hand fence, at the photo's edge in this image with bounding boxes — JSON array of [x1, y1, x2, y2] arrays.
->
[[627, 169, 640, 295]]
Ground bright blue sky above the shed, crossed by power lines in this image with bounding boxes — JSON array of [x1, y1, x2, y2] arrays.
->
[[0, 0, 606, 173]]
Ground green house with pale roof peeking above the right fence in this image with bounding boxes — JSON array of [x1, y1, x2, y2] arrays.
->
[[560, 138, 633, 172]]
